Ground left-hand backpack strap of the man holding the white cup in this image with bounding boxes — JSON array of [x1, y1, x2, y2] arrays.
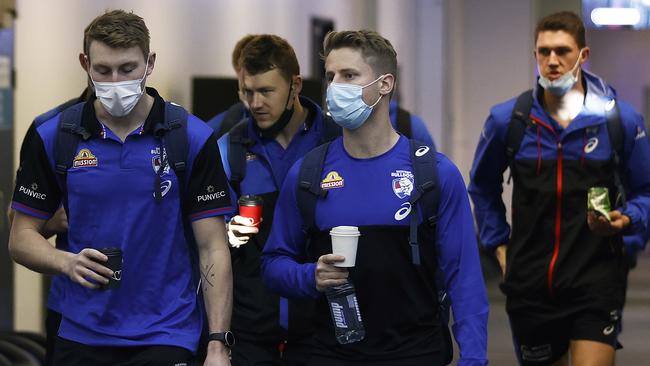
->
[[296, 142, 330, 233]]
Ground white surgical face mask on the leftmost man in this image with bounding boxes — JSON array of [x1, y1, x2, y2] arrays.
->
[[88, 57, 149, 117]]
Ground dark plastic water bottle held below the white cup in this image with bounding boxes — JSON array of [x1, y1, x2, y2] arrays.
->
[[325, 281, 366, 344]]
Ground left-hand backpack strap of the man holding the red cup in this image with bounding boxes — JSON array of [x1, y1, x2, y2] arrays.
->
[[228, 119, 255, 196]]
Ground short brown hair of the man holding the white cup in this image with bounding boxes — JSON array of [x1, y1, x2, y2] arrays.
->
[[323, 29, 397, 79]]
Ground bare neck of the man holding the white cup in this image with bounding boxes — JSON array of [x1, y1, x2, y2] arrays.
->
[[343, 103, 399, 159]]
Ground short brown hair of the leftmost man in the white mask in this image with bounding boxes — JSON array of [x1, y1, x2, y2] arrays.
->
[[84, 10, 150, 59]]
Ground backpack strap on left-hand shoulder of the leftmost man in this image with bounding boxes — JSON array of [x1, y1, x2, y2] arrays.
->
[[54, 103, 90, 177]]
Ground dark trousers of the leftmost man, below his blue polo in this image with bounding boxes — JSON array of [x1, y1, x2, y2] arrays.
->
[[54, 337, 193, 366]]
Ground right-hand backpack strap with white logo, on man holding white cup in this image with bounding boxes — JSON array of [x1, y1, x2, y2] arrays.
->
[[409, 140, 440, 265]]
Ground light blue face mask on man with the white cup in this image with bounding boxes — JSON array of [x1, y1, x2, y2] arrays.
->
[[327, 75, 385, 130]]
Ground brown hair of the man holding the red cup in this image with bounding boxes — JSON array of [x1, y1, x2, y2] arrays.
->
[[239, 34, 300, 83]]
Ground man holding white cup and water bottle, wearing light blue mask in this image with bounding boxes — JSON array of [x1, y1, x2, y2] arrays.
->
[[261, 30, 488, 366]]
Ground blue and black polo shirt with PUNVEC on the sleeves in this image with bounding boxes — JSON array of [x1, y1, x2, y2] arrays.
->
[[12, 88, 232, 351]]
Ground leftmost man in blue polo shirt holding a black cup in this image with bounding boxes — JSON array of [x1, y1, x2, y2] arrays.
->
[[9, 10, 232, 365]]
